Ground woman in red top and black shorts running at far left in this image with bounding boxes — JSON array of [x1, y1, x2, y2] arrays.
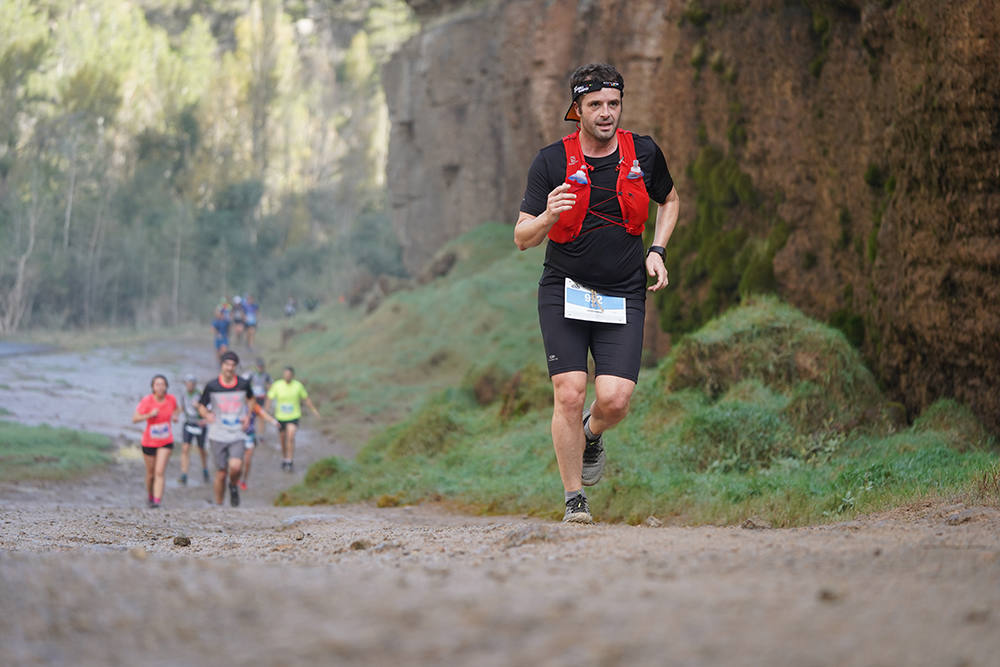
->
[[132, 375, 181, 508]]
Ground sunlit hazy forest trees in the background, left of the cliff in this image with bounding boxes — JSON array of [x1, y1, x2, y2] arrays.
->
[[0, 0, 416, 332]]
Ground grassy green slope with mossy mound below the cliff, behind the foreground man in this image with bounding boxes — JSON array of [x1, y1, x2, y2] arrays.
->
[[281, 225, 997, 525]]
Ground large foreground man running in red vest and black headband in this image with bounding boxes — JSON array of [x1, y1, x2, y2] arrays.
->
[[514, 64, 680, 523]]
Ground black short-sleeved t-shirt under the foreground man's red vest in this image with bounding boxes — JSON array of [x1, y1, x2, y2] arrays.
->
[[521, 134, 674, 298]]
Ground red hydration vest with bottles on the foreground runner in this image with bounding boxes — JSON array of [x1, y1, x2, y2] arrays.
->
[[549, 129, 649, 243]]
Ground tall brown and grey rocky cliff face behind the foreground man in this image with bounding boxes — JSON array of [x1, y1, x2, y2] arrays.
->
[[385, 0, 1000, 431]]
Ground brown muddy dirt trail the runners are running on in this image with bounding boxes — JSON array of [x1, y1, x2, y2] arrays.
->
[[0, 345, 1000, 666]]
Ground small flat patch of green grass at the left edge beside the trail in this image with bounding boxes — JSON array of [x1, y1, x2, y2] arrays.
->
[[0, 420, 112, 482]]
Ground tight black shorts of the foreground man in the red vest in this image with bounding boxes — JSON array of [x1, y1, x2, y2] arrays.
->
[[538, 283, 646, 382]]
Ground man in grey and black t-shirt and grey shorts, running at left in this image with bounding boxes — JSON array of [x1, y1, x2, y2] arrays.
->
[[198, 350, 277, 507]]
